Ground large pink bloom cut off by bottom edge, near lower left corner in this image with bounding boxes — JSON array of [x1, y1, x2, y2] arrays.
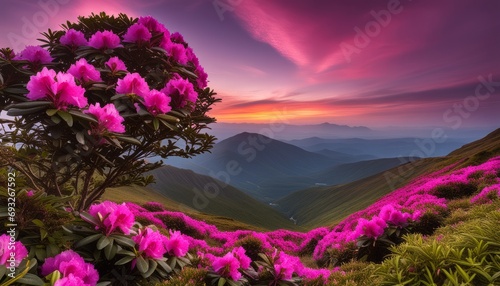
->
[[40, 250, 99, 286]]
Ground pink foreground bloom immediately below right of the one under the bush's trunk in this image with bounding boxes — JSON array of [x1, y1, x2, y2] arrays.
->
[[132, 228, 167, 259]]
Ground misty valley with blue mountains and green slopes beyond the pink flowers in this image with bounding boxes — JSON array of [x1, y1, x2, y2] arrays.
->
[[143, 125, 496, 229]]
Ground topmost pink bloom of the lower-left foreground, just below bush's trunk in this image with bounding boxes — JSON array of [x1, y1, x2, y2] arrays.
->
[[89, 201, 135, 235]]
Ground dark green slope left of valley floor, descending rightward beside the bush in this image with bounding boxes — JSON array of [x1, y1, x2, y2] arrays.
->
[[146, 166, 295, 229]]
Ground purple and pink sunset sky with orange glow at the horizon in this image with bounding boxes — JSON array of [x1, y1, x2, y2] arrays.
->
[[0, 0, 500, 127]]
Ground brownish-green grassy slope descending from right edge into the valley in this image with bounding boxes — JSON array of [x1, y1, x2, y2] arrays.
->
[[277, 129, 500, 228]]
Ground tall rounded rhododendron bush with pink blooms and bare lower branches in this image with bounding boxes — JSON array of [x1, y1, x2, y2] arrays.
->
[[0, 13, 218, 210]]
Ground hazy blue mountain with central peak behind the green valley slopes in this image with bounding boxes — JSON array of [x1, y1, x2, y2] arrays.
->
[[161, 132, 418, 202]]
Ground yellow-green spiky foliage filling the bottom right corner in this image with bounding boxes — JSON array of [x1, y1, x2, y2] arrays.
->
[[377, 204, 500, 285]]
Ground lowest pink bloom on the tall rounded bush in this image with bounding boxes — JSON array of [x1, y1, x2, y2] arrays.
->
[[84, 102, 125, 134]]
